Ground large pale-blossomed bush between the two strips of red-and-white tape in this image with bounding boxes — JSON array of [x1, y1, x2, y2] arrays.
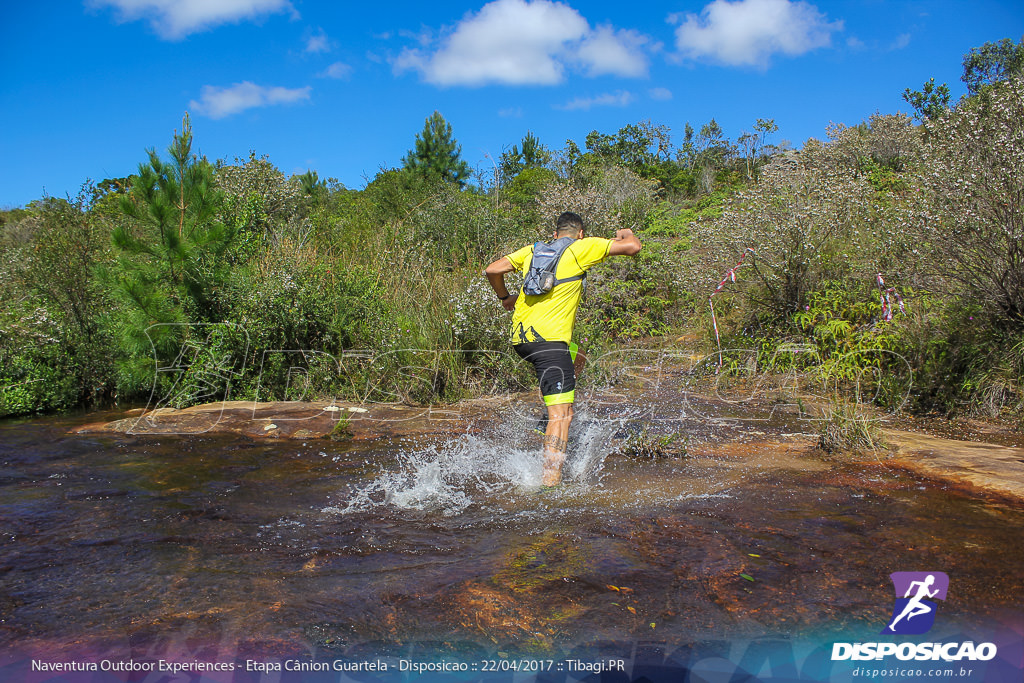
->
[[691, 116, 920, 321]]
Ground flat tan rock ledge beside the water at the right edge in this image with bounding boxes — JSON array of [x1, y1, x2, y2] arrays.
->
[[885, 430, 1024, 502]]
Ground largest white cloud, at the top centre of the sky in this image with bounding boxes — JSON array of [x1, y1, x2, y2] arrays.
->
[[393, 0, 648, 86]]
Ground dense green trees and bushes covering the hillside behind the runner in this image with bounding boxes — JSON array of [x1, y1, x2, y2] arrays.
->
[[0, 43, 1024, 428]]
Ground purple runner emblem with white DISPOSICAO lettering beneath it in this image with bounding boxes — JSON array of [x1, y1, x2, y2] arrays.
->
[[831, 571, 996, 661]]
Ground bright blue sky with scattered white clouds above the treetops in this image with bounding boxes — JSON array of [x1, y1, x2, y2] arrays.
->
[[0, 0, 1024, 208]]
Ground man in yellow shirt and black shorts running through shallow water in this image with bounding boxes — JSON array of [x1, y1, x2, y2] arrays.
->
[[484, 211, 641, 486]]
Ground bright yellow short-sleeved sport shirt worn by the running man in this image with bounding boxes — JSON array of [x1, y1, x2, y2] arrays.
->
[[506, 238, 611, 344]]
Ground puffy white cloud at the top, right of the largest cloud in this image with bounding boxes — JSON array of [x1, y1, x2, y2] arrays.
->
[[673, 0, 843, 69]]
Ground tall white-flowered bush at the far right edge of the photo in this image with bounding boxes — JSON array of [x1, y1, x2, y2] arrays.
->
[[880, 76, 1024, 418]]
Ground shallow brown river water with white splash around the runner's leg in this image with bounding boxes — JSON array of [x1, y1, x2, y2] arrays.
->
[[0, 407, 1024, 656]]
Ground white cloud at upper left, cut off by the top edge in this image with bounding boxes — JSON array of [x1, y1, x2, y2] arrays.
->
[[90, 0, 298, 40]]
